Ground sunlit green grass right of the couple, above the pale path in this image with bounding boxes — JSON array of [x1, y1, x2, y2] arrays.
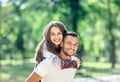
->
[[75, 62, 120, 78]]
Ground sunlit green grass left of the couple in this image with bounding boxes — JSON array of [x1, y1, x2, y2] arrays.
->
[[0, 60, 34, 82]]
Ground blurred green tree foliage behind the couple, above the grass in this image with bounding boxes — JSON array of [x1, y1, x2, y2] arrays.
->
[[0, 0, 120, 66]]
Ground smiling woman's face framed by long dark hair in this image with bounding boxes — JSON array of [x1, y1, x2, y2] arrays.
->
[[50, 26, 63, 46]]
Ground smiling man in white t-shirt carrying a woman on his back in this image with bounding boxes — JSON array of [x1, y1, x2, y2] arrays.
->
[[26, 32, 79, 82]]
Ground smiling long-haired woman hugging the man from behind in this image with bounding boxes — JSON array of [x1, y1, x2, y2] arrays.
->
[[35, 21, 80, 67]]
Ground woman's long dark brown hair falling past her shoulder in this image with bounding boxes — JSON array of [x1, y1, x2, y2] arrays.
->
[[35, 21, 67, 66]]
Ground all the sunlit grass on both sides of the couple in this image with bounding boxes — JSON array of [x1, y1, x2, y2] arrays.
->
[[0, 60, 120, 82]]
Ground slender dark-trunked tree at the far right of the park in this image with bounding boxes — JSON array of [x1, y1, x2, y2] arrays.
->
[[107, 0, 120, 68]]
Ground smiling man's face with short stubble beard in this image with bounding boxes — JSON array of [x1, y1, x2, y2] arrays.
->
[[61, 35, 79, 56]]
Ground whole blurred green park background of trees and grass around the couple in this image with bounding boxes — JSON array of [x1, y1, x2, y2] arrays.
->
[[0, 0, 120, 82]]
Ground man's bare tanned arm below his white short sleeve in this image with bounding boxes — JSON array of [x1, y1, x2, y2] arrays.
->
[[25, 71, 42, 82]]
